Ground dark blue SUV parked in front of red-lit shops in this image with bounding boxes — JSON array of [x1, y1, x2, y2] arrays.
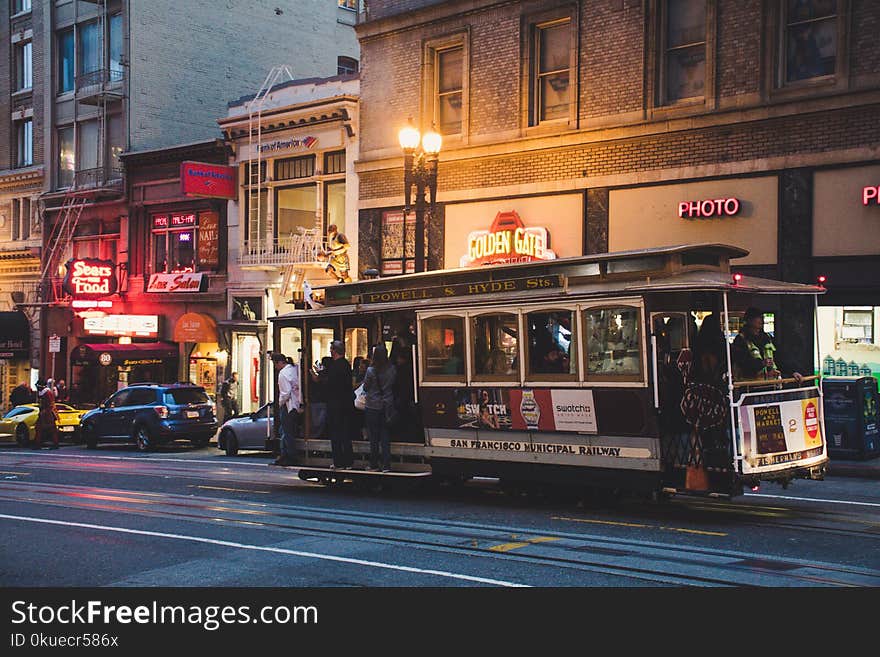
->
[[80, 383, 217, 452]]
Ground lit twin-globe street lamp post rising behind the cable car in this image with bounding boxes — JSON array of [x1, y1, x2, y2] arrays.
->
[[398, 119, 443, 274]]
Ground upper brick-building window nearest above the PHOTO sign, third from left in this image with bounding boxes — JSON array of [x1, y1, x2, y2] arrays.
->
[[660, 0, 706, 105]]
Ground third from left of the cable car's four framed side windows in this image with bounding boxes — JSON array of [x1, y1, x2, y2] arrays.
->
[[526, 310, 577, 380]]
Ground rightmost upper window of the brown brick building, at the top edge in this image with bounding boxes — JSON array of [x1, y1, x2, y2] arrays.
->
[[781, 0, 838, 83]]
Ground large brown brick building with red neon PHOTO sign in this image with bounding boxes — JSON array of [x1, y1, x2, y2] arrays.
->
[[357, 0, 880, 372]]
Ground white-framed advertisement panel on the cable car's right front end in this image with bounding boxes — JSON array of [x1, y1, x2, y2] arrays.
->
[[739, 388, 825, 471]]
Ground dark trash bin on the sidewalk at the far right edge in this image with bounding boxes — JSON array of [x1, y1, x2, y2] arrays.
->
[[822, 376, 880, 459]]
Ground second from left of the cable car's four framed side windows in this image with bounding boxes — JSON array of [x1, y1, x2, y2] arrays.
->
[[471, 313, 519, 381]]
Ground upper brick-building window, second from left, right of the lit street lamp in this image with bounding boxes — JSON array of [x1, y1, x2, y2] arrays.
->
[[530, 18, 572, 125]]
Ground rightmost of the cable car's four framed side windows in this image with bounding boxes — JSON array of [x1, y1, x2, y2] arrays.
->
[[584, 306, 642, 381]]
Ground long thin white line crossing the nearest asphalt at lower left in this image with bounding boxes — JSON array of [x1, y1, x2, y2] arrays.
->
[[0, 513, 528, 588]]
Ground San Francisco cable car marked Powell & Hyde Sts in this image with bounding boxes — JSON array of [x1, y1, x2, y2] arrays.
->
[[273, 244, 828, 497]]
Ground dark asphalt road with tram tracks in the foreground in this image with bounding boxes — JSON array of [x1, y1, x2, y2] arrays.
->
[[0, 446, 880, 587]]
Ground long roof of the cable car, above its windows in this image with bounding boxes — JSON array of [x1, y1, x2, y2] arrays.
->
[[271, 244, 825, 321]]
